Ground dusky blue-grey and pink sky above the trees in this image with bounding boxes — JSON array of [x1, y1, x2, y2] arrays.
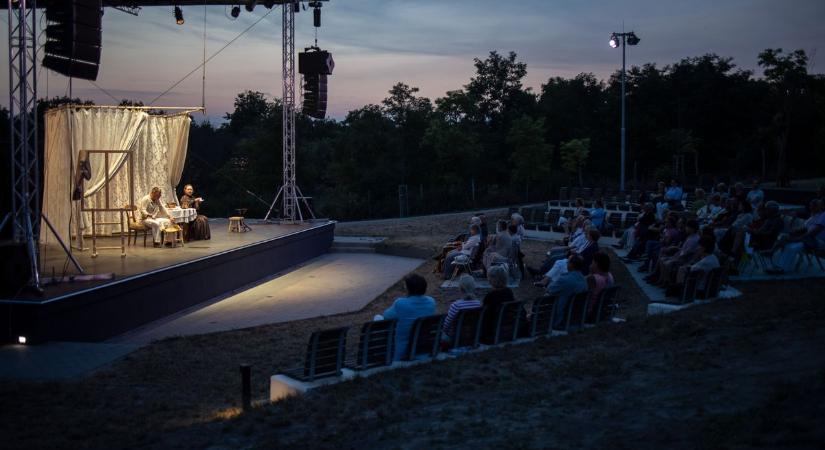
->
[[0, 0, 825, 120]]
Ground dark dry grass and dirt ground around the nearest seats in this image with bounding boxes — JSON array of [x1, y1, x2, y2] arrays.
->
[[0, 212, 825, 449]]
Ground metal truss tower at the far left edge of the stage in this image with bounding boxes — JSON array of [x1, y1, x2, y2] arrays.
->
[[0, 0, 40, 288]]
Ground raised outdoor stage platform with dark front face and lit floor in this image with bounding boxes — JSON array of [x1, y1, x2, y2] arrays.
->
[[0, 219, 335, 343]]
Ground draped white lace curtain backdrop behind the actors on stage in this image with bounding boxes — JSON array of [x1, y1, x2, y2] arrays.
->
[[40, 107, 191, 244]]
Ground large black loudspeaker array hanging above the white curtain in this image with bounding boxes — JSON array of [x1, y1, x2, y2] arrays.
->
[[43, 0, 103, 80]]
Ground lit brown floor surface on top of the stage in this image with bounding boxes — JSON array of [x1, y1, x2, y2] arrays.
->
[[36, 219, 322, 300]]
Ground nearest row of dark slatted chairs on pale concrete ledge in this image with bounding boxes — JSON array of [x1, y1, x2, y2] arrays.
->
[[283, 286, 620, 382]]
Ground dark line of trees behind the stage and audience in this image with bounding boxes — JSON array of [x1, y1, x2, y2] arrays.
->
[[0, 49, 825, 220]]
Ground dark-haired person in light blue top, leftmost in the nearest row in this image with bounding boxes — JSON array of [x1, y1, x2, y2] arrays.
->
[[382, 274, 435, 361]]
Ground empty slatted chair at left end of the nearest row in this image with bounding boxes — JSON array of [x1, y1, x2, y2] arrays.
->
[[284, 327, 349, 381]]
